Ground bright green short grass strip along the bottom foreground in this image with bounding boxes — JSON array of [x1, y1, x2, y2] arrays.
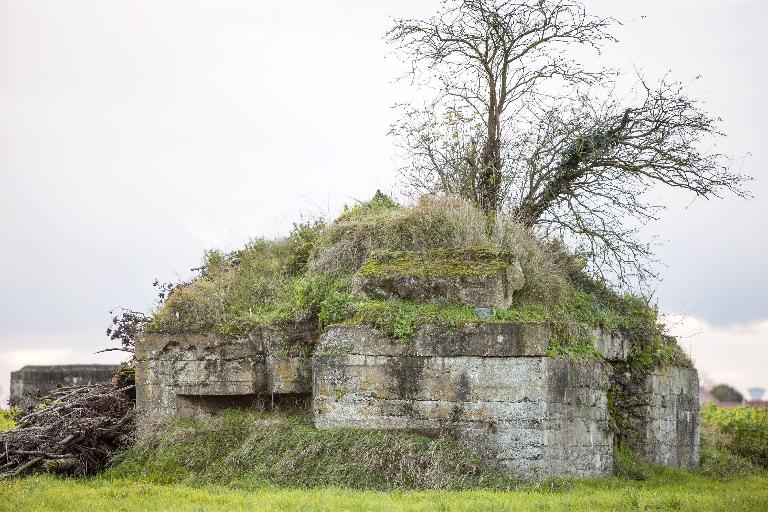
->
[[0, 469, 768, 512]]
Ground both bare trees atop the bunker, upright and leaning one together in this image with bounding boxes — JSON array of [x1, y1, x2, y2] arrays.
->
[[388, 0, 748, 284]]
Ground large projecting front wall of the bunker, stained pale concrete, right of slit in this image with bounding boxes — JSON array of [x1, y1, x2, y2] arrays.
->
[[313, 324, 613, 479]]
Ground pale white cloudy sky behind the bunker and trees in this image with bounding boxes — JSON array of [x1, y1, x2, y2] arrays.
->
[[0, 0, 768, 397]]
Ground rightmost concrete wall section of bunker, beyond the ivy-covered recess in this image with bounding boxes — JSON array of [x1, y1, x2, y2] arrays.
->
[[628, 366, 700, 469]]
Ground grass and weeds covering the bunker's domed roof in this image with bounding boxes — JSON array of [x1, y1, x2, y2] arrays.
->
[[148, 192, 682, 368]]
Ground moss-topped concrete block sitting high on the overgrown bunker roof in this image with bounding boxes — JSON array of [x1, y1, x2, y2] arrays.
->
[[352, 251, 525, 308]]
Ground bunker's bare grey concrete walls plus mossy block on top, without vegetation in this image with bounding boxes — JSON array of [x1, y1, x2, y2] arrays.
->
[[136, 247, 699, 480]]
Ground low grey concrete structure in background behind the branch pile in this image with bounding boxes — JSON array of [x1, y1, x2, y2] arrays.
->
[[10, 364, 118, 399]]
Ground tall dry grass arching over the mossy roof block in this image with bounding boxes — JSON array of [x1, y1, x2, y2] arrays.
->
[[309, 196, 567, 304]]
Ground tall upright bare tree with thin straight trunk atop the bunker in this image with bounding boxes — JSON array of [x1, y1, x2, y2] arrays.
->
[[388, 0, 611, 213]]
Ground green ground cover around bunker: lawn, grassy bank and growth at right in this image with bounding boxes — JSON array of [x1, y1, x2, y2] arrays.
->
[[0, 407, 768, 512]]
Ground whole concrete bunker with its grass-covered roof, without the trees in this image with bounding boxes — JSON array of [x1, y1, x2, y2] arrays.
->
[[135, 193, 699, 480]]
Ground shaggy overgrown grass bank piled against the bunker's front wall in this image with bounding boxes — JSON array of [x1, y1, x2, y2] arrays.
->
[[106, 410, 511, 490]]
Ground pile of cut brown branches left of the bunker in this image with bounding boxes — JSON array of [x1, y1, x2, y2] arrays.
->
[[0, 381, 134, 479]]
